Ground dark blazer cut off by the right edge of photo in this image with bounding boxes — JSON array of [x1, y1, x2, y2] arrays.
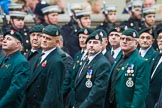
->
[[146, 54, 162, 108]]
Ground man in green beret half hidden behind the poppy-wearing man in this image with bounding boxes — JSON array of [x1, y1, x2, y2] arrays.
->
[[26, 24, 44, 66]]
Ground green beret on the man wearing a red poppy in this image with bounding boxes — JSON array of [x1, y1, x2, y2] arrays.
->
[[42, 25, 61, 37]]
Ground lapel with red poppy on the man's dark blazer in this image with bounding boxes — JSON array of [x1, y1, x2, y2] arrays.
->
[[28, 49, 56, 87]]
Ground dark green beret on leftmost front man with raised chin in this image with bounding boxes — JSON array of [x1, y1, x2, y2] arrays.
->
[[3, 30, 22, 43]]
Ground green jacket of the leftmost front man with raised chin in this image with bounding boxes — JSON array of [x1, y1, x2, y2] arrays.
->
[[0, 51, 30, 108]]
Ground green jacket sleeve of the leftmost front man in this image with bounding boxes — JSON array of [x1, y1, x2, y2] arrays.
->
[[0, 62, 30, 108]]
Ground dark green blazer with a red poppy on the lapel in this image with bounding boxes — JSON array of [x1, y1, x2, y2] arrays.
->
[[21, 49, 65, 108]]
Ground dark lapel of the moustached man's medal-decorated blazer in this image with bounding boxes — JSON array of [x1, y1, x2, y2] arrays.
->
[[75, 53, 101, 87]]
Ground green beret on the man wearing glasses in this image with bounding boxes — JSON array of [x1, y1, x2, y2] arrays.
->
[[122, 28, 139, 38]]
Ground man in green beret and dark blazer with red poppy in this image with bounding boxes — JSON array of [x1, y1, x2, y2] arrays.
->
[[22, 25, 65, 108]]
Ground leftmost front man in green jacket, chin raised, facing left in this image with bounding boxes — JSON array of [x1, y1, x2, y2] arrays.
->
[[0, 30, 30, 108]]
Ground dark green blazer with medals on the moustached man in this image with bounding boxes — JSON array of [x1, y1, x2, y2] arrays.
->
[[74, 53, 110, 108]]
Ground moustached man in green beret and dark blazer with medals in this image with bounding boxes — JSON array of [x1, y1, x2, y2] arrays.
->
[[74, 32, 111, 108]]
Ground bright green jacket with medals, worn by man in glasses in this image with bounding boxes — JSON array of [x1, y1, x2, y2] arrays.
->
[[105, 50, 150, 108]]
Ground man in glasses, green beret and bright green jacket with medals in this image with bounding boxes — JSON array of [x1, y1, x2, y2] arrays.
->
[[105, 29, 150, 108]]
